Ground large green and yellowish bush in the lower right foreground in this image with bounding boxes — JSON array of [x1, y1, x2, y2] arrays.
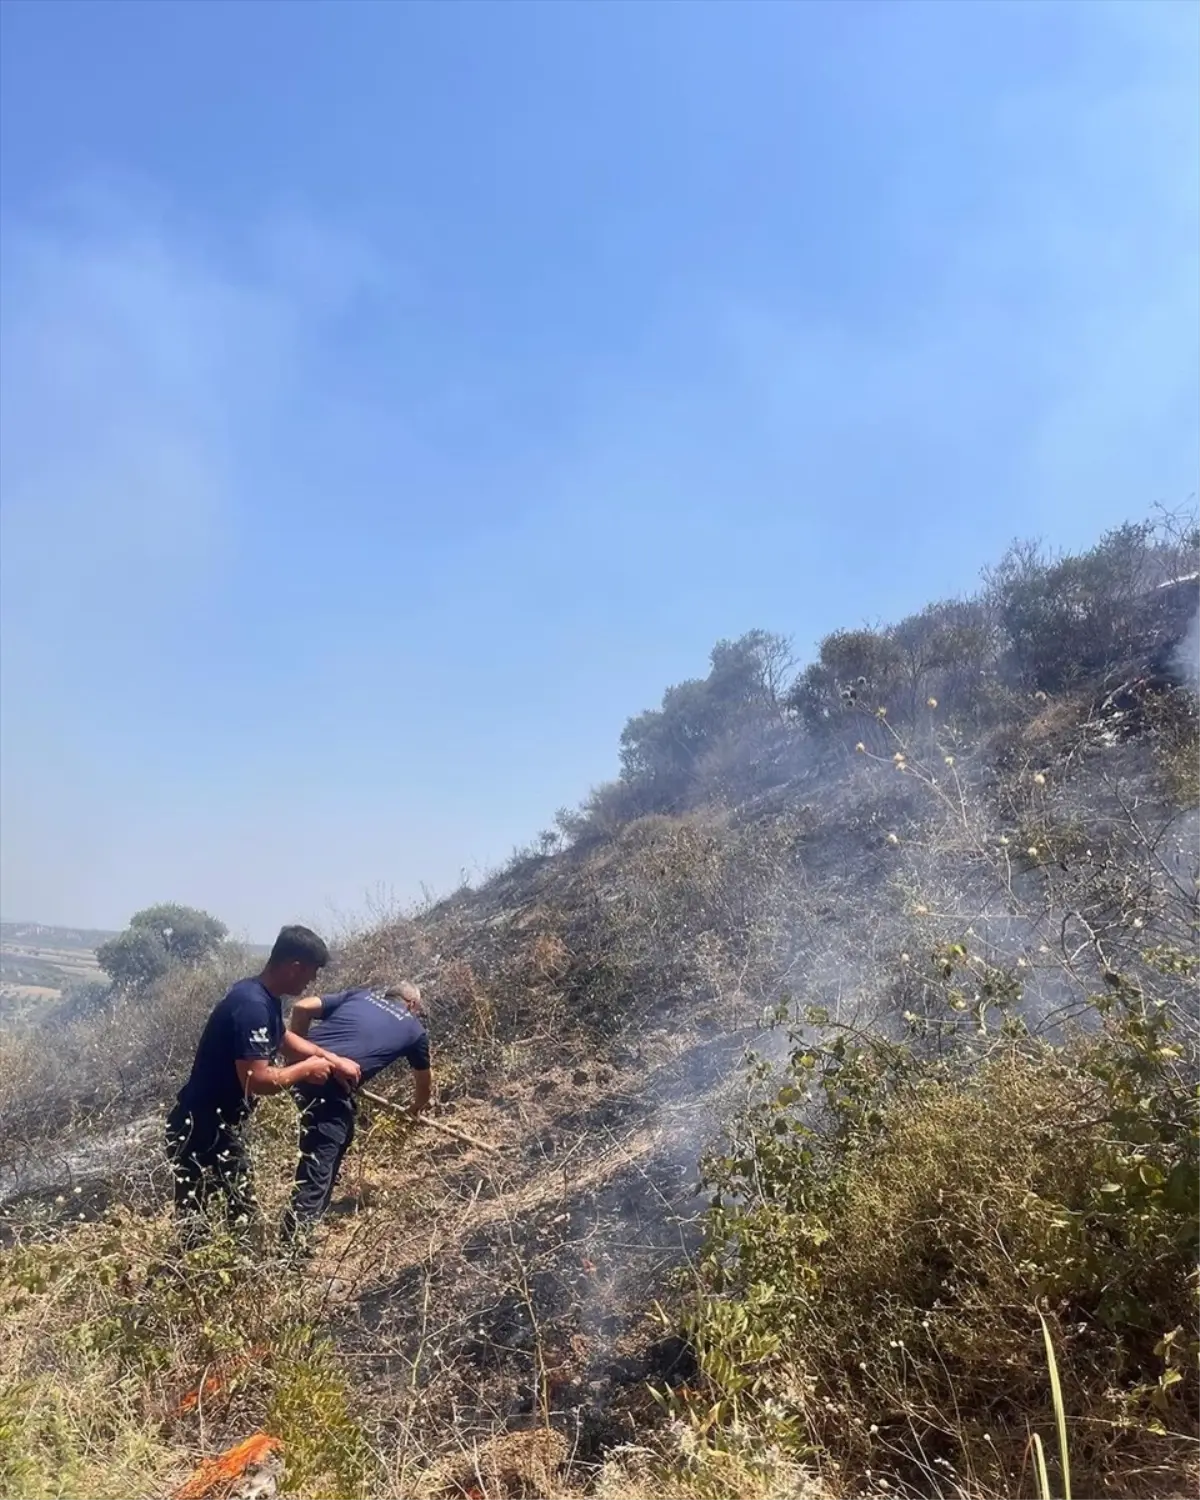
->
[[684, 954, 1200, 1496]]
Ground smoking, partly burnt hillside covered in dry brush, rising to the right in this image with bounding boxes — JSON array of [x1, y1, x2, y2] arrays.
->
[[0, 530, 1200, 1500]]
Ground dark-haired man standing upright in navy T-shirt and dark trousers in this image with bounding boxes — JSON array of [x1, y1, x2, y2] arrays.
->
[[167, 927, 359, 1223]]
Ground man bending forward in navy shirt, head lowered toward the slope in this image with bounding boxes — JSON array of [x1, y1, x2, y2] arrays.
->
[[284, 981, 432, 1239]]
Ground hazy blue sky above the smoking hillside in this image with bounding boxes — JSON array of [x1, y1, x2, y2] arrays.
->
[[0, 0, 1200, 938]]
